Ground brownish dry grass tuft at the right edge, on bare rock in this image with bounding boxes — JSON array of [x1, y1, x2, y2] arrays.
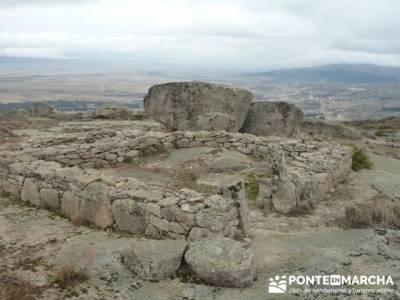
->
[[345, 197, 400, 228]]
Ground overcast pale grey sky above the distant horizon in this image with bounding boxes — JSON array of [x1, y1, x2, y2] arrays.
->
[[0, 0, 400, 70]]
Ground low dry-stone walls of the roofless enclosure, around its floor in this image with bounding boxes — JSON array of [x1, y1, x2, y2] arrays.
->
[[0, 121, 351, 240]]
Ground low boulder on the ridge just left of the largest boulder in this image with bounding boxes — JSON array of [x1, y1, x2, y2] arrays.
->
[[93, 104, 144, 120]]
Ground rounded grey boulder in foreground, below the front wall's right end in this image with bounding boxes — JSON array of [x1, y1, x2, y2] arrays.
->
[[185, 237, 256, 287]]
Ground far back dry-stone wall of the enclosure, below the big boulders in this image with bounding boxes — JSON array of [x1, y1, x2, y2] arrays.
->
[[3, 131, 281, 168]]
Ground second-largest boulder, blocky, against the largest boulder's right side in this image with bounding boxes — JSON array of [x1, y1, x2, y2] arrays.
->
[[240, 102, 304, 136]]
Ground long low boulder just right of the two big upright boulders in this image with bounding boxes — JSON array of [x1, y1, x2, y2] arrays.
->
[[299, 118, 361, 141]]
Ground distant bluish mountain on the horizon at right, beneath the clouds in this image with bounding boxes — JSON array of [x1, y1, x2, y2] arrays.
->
[[251, 64, 400, 84]]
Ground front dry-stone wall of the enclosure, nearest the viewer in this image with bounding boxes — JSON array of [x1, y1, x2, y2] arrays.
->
[[0, 160, 247, 239]]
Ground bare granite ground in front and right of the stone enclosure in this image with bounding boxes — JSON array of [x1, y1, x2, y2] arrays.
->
[[0, 152, 400, 300]]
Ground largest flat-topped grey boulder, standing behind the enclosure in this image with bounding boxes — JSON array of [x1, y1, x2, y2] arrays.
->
[[144, 81, 253, 132]]
